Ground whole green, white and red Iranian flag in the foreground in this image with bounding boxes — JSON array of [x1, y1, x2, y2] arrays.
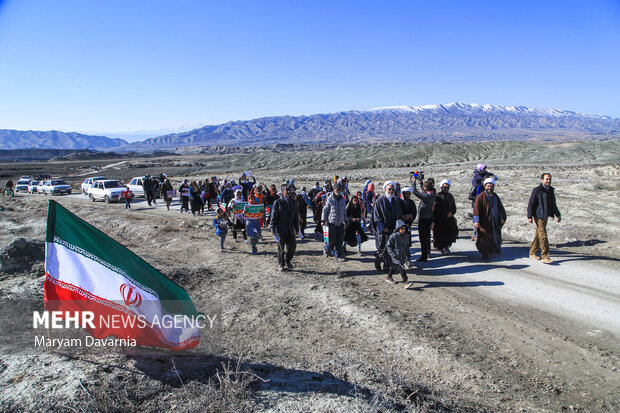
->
[[44, 201, 201, 350]]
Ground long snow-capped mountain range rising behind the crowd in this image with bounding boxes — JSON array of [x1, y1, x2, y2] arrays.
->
[[121, 103, 620, 151]]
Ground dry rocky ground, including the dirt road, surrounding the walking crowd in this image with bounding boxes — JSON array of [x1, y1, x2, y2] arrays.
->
[[0, 141, 620, 412]]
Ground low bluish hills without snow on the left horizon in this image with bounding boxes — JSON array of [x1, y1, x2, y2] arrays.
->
[[0, 129, 127, 150]]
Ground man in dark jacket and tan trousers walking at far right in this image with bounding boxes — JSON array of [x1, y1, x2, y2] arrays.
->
[[527, 173, 562, 264]]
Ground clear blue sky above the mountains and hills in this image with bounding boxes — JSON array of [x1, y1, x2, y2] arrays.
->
[[0, 0, 620, 140]]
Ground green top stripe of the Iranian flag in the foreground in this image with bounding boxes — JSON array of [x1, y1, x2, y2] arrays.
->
[[46, 200, 198, 316]]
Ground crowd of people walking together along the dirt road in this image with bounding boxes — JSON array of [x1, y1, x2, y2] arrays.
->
[[2, 164, 561, 286]]
